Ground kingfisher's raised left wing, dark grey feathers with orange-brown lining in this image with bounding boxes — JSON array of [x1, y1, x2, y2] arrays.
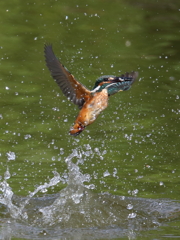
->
[[44, 45, 90, 108]]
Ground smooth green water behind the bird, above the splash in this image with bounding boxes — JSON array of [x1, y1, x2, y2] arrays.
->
[[0, 0, 180, 236]]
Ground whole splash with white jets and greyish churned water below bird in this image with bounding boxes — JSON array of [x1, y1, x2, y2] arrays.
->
[[0, 145, 180, 239]]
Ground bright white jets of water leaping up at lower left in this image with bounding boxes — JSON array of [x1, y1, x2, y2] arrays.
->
[[0, 150, 97, 225]]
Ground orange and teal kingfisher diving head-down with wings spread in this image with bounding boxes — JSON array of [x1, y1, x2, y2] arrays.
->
[[44, 44, 138, 136]]
